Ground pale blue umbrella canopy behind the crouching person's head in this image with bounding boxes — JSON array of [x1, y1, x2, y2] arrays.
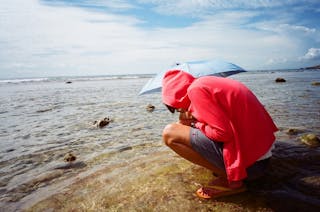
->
[[139, 59, 245, 95]]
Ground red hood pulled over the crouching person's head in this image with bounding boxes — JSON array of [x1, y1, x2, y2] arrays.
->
[[162, 70, 195, 110]]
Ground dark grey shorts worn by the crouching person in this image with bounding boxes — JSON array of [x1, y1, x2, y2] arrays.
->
[[190, 128, 270, 180]]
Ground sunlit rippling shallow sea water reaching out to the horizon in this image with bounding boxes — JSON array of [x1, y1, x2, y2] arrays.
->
[[0, 70, 320, 211]]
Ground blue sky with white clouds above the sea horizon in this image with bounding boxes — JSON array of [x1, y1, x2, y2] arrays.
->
[[0, 0, 320, 78]]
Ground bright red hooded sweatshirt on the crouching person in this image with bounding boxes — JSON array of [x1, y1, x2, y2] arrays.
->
[[162, 70, 278, 181]]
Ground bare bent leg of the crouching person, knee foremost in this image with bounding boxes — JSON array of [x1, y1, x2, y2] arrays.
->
[[162, 123, 226, 178]]
